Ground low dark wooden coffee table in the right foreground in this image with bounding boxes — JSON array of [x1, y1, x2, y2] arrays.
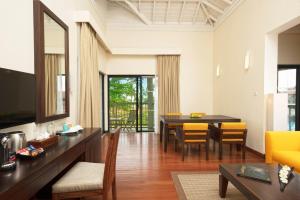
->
[[219, 163, 300, 200]]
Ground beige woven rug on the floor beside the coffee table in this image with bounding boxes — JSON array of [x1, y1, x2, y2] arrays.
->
[[172, 172, 246, 200]]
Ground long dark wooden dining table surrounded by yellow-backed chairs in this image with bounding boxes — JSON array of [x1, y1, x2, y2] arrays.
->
[[159, 115, 241, 152]]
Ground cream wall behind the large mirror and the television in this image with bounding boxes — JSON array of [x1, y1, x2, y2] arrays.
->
[[0, 0, 106, 139]]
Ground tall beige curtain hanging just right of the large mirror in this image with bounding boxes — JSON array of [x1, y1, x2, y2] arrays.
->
[[79, 23, 100, 127]]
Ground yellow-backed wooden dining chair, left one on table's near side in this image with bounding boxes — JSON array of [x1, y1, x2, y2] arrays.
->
[[175, 123, 210, 161]]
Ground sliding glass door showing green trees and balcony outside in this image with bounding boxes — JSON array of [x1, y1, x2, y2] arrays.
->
[[108, 75, 155, 132]]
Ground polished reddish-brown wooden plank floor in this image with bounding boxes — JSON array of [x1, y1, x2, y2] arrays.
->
[[99, 133, 263, 200]]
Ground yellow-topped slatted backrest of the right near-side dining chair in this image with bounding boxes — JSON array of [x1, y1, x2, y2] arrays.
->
[[220, 122, 247, 142]]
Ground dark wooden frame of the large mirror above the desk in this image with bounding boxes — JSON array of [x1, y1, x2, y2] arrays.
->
[[33, 0, 70, 123]]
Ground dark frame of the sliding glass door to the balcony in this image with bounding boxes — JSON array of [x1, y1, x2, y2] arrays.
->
[[107, 74, 155, 132]]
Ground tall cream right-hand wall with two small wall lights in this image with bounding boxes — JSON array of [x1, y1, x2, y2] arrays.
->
[[214, 0, 300, 152]]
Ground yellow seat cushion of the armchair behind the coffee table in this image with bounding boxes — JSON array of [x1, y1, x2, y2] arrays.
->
[[272, 151, 300, 172]]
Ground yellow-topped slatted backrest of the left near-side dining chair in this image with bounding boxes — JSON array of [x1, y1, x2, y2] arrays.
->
[[182, 123, 209, 142]]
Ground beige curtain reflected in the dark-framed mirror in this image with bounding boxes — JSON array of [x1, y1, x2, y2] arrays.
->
[[45, 54, 59, 116]]
